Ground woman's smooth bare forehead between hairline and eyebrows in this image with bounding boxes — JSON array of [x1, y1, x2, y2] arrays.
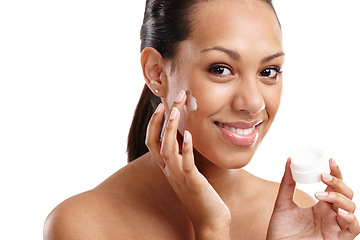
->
[[184, 0, 282, 54]]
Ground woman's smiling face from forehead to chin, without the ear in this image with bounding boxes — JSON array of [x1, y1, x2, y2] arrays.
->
[[165, 0, 284, 169]]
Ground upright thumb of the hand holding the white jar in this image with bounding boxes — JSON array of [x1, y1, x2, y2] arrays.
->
[[274, 158, 296, 211]]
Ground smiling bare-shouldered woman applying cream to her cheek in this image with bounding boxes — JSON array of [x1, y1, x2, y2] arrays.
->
[[44, 0, 360, 240]]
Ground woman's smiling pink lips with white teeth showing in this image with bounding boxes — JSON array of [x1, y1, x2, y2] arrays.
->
[[215, 121, 262, 146]]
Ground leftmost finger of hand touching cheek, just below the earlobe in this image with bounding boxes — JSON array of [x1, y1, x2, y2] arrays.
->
[[145, 103, 165, 168]]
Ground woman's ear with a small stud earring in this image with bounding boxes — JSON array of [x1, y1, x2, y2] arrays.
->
[[141, 47, 166, 97]]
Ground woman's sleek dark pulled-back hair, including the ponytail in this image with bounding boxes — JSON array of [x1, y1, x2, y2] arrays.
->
[[127, 0, 273, 162]]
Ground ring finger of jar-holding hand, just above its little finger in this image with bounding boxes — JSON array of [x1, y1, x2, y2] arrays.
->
[[315, 192, 356, 213]]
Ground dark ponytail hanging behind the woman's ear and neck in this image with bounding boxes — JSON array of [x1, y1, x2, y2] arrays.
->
[[127, 85, 161, 162]]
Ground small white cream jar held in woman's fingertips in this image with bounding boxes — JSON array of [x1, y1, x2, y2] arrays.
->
[[290, 148, 330, 184]]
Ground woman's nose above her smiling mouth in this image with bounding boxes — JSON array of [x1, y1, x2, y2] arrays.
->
[[232, 80, 265, 115]]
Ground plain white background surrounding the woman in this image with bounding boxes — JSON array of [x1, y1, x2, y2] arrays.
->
[[0, 0, 360, 239]]
